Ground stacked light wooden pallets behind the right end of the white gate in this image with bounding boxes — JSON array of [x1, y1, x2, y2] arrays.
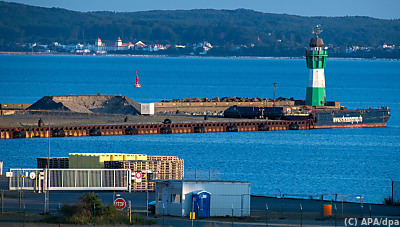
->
[[104, 156, 184, 191]]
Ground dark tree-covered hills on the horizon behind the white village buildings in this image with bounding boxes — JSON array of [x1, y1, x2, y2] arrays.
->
[[0, 1, 400, 50]]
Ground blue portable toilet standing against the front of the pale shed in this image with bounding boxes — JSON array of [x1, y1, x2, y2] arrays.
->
[[192, 190, 211, 218]]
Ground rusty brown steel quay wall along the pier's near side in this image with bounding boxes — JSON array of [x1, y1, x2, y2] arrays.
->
[[0, 120, 310, 139]]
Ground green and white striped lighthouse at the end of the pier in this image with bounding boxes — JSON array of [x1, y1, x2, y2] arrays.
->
[[306, 25, 328, 106]]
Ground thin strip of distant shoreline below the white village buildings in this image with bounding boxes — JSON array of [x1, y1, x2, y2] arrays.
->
[[0, 51, 400, 61]]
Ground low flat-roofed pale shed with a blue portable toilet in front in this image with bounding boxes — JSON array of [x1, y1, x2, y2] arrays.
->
[[155, 180, 250, 217]]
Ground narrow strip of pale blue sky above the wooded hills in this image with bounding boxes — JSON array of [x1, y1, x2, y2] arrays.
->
[[6, 0, 400, 19]]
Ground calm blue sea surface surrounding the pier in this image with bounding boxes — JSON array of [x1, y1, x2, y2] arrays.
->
[[0, 55, 400, 203]]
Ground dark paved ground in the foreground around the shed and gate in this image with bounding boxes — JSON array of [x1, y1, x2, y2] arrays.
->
[[0, 191, 400, 227]]
